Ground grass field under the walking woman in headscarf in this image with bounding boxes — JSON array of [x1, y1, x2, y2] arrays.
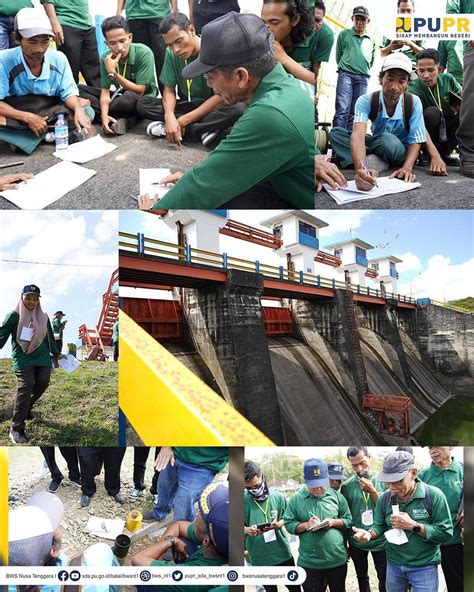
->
[[0, 359, 118, 446]]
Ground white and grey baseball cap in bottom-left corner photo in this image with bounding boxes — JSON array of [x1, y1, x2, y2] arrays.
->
[[8, 491, 64, 566]]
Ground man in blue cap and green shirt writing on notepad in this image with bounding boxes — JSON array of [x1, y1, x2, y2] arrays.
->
[[283, 458, 352, 592]]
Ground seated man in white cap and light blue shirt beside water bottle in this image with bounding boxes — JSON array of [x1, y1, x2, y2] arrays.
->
[[0, 8, 92, 150]]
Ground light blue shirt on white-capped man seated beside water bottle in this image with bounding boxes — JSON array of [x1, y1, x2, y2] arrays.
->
[[0, 47, 79, 102]]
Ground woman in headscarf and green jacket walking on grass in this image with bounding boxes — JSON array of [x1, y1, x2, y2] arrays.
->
[[0, 285, 66, 444]]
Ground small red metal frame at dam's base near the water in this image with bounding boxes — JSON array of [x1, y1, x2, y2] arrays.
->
[[362, 394, 411, 436]]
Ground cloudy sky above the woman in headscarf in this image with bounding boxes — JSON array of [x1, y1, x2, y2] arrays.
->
[[0, 210, 118, 357]]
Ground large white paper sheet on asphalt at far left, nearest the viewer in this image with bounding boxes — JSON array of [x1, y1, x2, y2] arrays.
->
[[0, 162, 95, 210]]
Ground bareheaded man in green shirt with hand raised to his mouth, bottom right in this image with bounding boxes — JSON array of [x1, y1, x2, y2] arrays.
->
[[341, 446, 387, 592]]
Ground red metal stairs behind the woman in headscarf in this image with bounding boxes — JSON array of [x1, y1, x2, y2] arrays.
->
[[79, 269, 119, 360]]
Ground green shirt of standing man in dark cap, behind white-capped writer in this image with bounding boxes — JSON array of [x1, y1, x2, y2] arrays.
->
[[336, 27, 376, 76]]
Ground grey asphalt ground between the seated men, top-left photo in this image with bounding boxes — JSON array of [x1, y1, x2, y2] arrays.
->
[[0, 121, 209, 210]]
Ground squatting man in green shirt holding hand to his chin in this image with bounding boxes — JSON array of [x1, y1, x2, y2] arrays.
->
[[79, 16, 157, 134]]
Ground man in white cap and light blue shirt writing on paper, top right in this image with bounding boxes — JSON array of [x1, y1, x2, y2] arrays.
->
[[330, 54, 426, 191]]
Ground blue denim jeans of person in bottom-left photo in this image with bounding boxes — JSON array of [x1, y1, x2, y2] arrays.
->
[[153, 458, 215, 522]]
